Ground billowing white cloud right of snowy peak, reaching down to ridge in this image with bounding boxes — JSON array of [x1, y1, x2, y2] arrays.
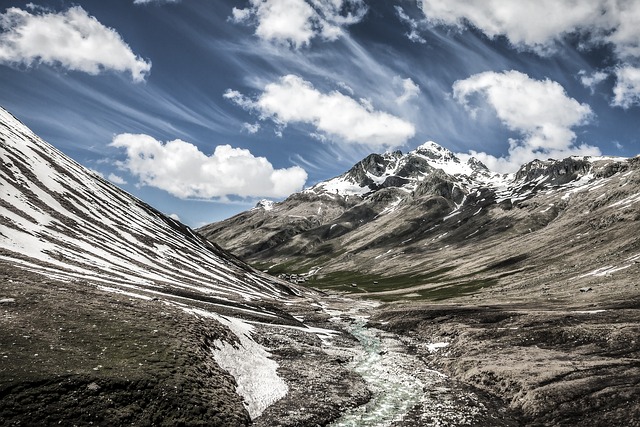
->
[[453, 71, 600, 172]]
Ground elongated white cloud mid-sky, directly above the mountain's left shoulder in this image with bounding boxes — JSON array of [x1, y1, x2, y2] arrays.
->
[[224, 75, 415, 148]]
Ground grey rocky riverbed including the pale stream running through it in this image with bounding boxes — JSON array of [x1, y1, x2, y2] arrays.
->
[[255, 296, 520, 427]]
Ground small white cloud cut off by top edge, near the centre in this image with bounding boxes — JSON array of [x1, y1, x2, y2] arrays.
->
[[231, 0, 367, 48]]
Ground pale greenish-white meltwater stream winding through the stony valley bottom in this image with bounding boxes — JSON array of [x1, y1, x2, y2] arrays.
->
[[330, 318, 424, 427]]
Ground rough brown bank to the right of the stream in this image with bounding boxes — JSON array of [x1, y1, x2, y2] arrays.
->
[[375, 299, 640, 427]]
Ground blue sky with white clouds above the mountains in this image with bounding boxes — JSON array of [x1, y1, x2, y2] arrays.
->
[[0, 0, 640, 227]]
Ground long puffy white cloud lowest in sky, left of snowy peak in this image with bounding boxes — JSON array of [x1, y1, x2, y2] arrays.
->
[[111, 134, 307, 199]]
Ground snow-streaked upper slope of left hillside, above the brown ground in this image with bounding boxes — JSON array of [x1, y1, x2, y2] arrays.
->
[[0, 106, 294, 301]]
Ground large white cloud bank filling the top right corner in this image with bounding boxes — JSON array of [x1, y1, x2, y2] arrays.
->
[[420, 0, 640, 108]]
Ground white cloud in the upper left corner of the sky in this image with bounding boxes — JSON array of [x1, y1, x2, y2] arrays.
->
[[0, 6, 151, 82]]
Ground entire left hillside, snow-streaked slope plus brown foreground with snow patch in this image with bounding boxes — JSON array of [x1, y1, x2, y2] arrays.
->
[[0, 109, 369, 426]]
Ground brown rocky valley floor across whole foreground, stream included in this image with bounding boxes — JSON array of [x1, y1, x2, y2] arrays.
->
[[0, 264, 640, 427]]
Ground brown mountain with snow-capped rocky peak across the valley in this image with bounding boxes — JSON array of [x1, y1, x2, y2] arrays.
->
[[199, 143, 640, 300]]
